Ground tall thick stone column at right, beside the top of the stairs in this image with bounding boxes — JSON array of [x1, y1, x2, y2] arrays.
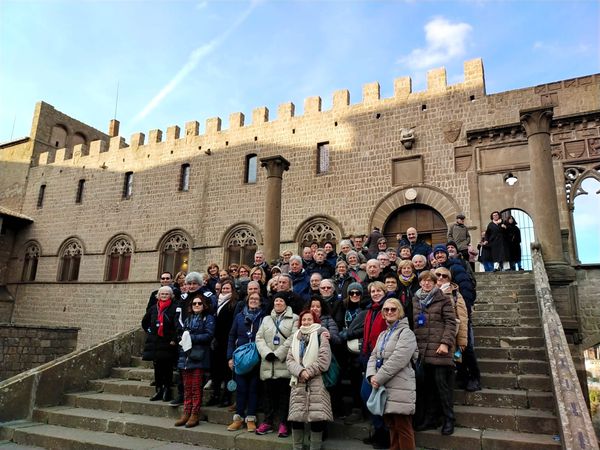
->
[[520, 106, 574, 278]]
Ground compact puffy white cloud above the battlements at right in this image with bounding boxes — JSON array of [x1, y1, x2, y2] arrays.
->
[[398, 17, 473, 69]]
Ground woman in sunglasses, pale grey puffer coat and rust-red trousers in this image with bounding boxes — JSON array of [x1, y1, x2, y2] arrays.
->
[[365, 298, 419, 450]]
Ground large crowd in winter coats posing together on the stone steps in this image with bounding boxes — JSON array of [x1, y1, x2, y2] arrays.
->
[[142, 222, 488, 449]]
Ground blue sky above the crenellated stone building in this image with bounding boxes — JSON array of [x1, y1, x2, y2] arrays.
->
[[0, 0, 600, 262]]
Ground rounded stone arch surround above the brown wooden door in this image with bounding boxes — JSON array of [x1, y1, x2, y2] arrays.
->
[[369, 185, 463, 230]]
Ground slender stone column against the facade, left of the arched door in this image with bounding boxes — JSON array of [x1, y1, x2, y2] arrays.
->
[[260, 155, 290, 261]]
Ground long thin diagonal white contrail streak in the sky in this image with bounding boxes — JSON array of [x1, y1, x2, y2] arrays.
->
[[131, 0, 261, 125]]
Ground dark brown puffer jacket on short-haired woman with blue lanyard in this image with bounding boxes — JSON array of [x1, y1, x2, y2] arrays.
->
[[413, 288, 456, 366]]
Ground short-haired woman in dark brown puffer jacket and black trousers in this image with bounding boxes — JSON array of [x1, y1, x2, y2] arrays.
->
[[413, 271, 456, 435]]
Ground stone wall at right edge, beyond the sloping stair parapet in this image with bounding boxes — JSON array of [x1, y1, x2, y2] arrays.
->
[[577, 265, 600, 349]]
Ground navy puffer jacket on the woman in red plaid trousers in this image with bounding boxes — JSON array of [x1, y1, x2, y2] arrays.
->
[[177, 314, 215, 369]]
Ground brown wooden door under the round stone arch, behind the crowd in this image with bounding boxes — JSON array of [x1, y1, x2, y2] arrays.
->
[[382, 203, 448, 246]]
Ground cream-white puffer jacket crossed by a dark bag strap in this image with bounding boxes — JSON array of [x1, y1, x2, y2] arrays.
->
[[256, 306, 298, 380]]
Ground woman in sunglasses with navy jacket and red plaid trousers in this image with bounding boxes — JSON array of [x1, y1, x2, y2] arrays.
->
[[175, 297, 215, 428]]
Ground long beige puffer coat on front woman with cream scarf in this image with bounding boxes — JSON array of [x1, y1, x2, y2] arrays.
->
[[286, 328, 333, 422]]
